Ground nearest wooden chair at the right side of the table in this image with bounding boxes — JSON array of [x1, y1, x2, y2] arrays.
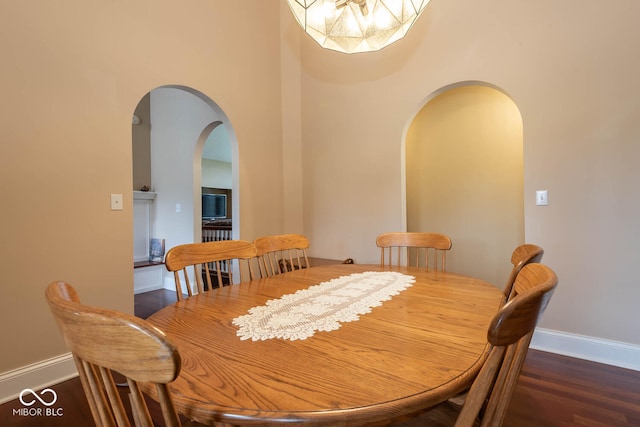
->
[[393, 263, 558, 427]]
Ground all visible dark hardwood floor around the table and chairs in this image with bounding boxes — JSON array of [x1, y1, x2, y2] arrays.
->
[[0, 291, 640, 427]]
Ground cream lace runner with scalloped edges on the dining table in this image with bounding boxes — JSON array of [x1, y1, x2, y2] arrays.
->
[[233, 271, 415, 341]]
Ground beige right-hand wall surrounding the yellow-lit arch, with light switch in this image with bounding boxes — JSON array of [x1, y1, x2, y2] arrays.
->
[[290, 0, 640, 345]]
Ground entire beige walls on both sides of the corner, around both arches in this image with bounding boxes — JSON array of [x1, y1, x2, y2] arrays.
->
[[0, 0, 640, 388]]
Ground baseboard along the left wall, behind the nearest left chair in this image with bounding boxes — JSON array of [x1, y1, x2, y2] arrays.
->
[[0, 353, 78, 404]]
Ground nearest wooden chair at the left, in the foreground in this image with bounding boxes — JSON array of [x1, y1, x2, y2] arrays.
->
[[45, 282, 192, 427]]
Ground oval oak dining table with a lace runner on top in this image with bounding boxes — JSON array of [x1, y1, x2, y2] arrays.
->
[[148, 264, 502, 426]]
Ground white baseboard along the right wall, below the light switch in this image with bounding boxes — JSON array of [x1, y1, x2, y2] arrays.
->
[[531, 328, 640, 371]]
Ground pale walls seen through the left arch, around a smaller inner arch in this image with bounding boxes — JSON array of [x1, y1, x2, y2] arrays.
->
[[132, 86, 240, 289]]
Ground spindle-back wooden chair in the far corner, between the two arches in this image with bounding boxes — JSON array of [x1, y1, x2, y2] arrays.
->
[[253, 234, 311, 277]]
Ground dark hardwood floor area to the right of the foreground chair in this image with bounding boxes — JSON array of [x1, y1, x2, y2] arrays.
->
[[504, 350, 640, 427]]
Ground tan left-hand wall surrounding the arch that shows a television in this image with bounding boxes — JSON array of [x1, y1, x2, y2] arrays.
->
[[0, 0, 282, 372]]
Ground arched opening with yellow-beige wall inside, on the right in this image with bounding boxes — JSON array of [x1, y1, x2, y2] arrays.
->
[[405, 83, 524, 286]]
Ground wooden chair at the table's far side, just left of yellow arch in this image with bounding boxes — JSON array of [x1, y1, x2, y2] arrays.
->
[[376, 232, 451, 271]]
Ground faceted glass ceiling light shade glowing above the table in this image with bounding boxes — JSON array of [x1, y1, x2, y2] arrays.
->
[[287, 0, 429, 53]]
